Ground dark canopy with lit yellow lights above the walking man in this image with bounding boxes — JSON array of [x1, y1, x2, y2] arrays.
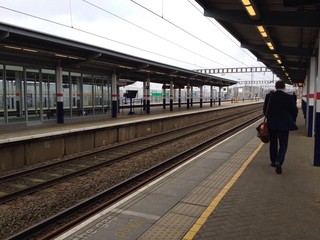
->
[[196, 0, 320, 84]]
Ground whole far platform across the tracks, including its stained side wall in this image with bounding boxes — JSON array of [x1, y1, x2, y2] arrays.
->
[[0, 100, 263, 174]]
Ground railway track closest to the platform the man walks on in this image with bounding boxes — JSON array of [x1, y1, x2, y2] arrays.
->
[[8, 115, 262, 240]]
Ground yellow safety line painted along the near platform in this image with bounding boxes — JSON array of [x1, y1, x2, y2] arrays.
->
[[183, 143, 263, 240]]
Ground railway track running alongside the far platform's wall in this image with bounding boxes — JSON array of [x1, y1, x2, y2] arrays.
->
[[0, 106, 262, 204]]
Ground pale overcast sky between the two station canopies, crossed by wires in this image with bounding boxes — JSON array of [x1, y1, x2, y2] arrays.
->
[[0, 0, 272, 85]]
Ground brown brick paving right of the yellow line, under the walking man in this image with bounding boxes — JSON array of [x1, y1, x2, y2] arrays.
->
[[192, 111, 320, 240]]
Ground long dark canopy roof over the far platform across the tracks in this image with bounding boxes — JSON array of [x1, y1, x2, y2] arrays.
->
[[0, 23, 237, 88]]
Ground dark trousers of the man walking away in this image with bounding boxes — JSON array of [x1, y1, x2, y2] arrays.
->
[[269, 130, 289, 165]]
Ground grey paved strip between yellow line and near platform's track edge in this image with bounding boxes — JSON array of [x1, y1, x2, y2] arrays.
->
[[57, 101, 260, 240]]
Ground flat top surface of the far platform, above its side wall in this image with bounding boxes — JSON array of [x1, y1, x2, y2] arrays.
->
[[0, 100, 255, 144]]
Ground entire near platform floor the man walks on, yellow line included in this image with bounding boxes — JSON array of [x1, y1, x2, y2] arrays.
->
[[53, 106, 320, 240]]
